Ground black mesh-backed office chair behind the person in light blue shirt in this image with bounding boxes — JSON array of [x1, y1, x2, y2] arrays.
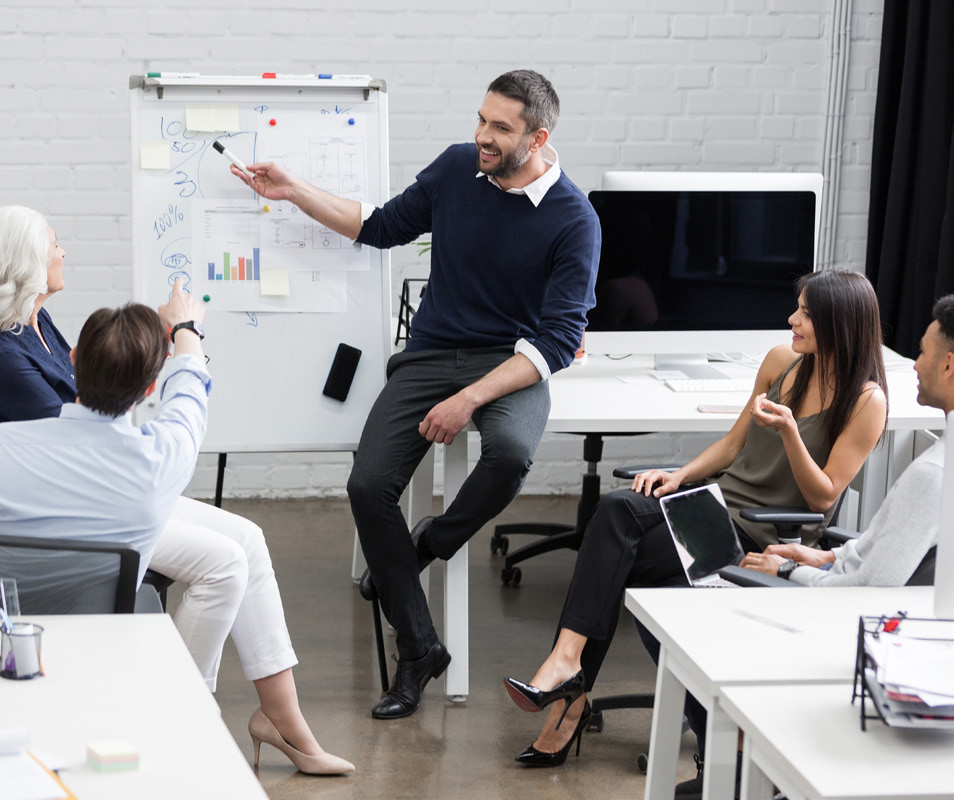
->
[[0, 536, 162, 614]]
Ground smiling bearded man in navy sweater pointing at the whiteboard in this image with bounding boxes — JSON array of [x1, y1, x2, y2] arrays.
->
[[232, 70, 600, 719]]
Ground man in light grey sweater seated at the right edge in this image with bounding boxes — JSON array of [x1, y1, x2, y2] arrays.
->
[[742, 294, 954, 586]]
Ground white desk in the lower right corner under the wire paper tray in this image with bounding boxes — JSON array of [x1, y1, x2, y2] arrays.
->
[[721, 684, 954, 800]]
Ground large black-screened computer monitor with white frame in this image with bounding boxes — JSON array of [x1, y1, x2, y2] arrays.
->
[[587, 173, 822, 376]]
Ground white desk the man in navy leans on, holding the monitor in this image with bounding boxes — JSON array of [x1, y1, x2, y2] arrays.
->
[[360, 350, 944, 700]]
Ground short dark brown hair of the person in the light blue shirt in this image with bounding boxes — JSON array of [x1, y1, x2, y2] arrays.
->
[[74, 303, 169, 417]]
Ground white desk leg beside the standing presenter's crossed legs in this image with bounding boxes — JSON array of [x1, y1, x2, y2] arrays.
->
[[444, 431, 470, 703]]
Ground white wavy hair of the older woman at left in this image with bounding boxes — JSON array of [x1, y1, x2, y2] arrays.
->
[[0, 206, 50, 333]]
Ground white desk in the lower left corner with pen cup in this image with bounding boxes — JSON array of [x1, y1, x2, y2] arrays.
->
[[0, 614, 267, 800]]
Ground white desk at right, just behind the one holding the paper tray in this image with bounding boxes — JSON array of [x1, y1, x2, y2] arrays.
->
[[625, 587, 934, 800]]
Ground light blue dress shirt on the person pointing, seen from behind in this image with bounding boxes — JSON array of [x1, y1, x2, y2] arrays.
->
[[0, 355, 212, 585]]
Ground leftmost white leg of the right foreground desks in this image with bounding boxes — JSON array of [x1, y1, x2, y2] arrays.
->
[[645, 648, 686, 800]]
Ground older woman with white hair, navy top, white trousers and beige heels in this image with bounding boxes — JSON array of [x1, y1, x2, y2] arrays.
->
[[0, 206, 354, 775]]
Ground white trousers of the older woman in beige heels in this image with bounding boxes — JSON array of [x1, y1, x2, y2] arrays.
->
[[149, 497, 298, 692]]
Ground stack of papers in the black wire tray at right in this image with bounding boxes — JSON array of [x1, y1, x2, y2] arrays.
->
[[864, 619, 954, 730]]
